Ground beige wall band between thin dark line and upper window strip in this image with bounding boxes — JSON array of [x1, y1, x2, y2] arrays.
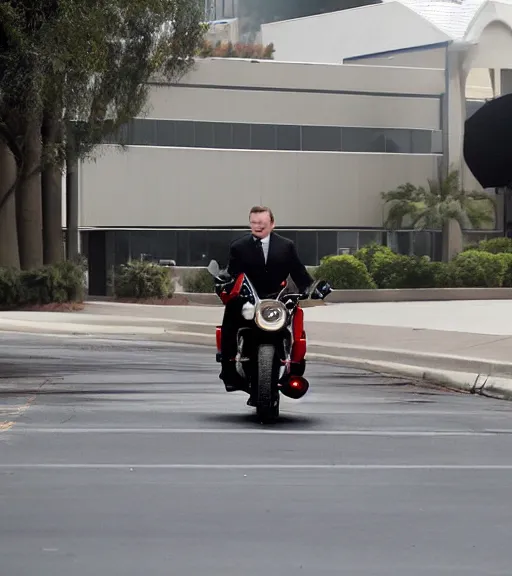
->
[[145, 84, 441, 130]]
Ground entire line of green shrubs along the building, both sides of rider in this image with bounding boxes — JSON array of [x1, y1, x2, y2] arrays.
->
[[5, 238, 512, 310]]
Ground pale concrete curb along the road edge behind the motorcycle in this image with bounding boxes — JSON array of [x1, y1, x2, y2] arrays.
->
[[0, 320, 512, 400]]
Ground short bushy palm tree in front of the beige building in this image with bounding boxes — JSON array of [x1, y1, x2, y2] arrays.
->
[[381, 170, 496, 261]]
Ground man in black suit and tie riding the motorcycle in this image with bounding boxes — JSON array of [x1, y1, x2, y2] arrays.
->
[[219, 206, 313, 392]]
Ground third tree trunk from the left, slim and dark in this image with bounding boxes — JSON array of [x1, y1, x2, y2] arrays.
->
[[41, 114, 64, 264]]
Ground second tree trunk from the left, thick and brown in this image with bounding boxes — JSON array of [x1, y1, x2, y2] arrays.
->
[[16, 120, 43, 270]]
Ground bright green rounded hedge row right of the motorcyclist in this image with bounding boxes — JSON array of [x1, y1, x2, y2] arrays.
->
[[315, 238, 512, 290]]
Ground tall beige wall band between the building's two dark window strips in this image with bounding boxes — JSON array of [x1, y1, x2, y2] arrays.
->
[[80, 146, 437, 227]]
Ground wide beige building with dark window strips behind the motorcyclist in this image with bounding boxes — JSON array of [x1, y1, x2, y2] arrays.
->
[[79, 58, 445, 292]]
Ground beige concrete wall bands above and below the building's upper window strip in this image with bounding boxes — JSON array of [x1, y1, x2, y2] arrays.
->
[[80, 59, 444, 228]]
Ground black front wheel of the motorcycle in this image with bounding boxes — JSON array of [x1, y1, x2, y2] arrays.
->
[[256, 344, 280, 422]]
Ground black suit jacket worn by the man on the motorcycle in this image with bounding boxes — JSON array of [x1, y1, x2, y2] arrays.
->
[[228, 232, 313, 297]]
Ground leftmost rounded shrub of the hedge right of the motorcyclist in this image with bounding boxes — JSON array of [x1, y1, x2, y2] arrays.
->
[[315, 254, 376, 290]]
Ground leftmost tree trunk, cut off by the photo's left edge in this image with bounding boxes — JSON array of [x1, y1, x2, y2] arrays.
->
[[0, 140, 20, 268]]
